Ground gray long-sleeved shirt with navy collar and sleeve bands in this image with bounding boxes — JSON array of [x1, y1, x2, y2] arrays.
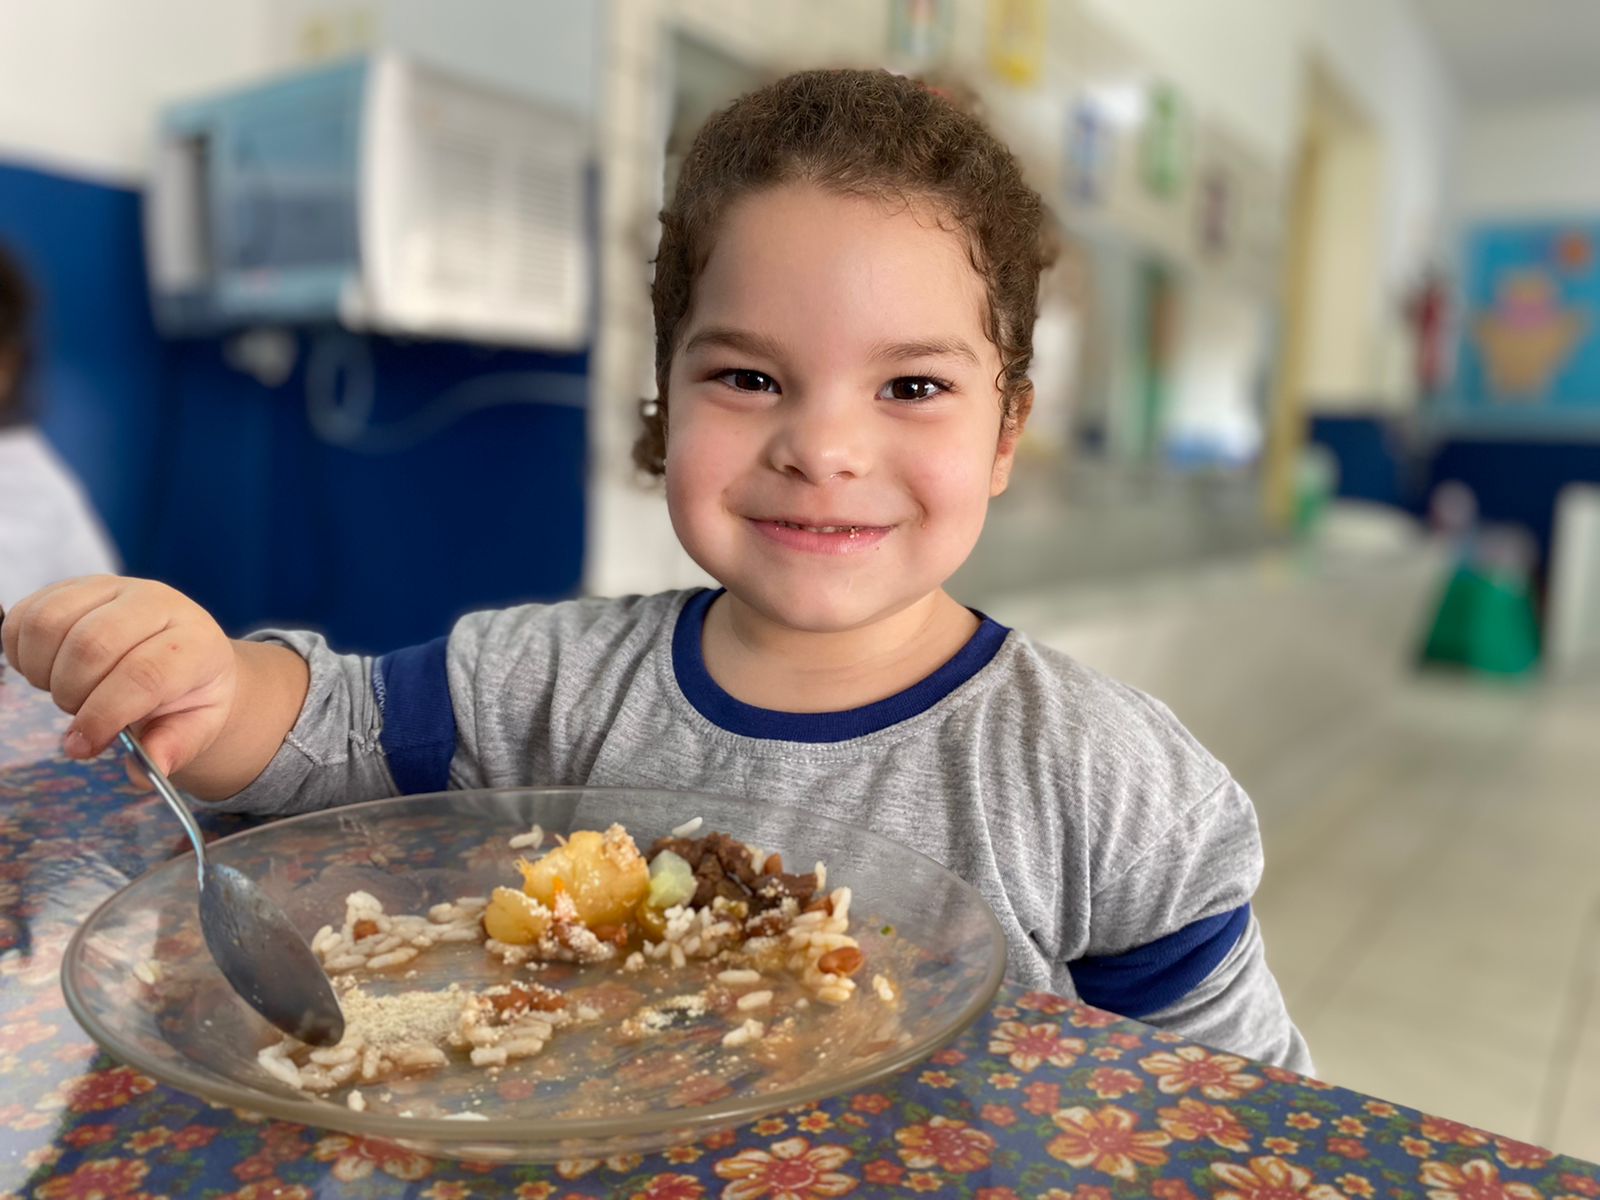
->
[[233, 590, 1310, 1074]]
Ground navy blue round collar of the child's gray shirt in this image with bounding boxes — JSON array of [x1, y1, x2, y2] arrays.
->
[[672, 589, 1011, 742]]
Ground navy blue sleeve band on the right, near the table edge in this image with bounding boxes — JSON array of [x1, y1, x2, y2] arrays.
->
[[1067, 904, 1250, 1019]]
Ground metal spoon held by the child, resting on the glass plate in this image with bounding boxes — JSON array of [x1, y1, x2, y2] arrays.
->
[[117, 730, 344, 1046]]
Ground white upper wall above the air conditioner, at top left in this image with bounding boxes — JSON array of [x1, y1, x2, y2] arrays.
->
[[0, 0, 603, 186]]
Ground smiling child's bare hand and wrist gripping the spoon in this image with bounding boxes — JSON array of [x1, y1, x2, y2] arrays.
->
[[0, 576, 309, 798]]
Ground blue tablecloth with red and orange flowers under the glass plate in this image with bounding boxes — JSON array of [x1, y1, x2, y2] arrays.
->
[[0, 674, 1600, 1200]]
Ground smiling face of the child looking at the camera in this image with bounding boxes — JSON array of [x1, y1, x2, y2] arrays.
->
[[667, 184, 1014, 632]]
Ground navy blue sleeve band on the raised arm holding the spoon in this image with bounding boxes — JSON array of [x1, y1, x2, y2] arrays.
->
[[373, 637, 456, 795]]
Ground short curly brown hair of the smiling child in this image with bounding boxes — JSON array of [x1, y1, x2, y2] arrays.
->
[[634, 70, 1053, 475]]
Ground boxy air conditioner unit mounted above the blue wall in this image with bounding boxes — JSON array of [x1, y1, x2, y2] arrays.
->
[[146, 53, 592, 349]]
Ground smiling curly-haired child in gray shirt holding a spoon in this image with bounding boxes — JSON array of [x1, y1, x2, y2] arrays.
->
[[3, 70, 1310, 1070]]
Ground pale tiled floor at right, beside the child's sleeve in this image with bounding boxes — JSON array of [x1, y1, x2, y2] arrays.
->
[[1256, 680, 1600, 1160]]
